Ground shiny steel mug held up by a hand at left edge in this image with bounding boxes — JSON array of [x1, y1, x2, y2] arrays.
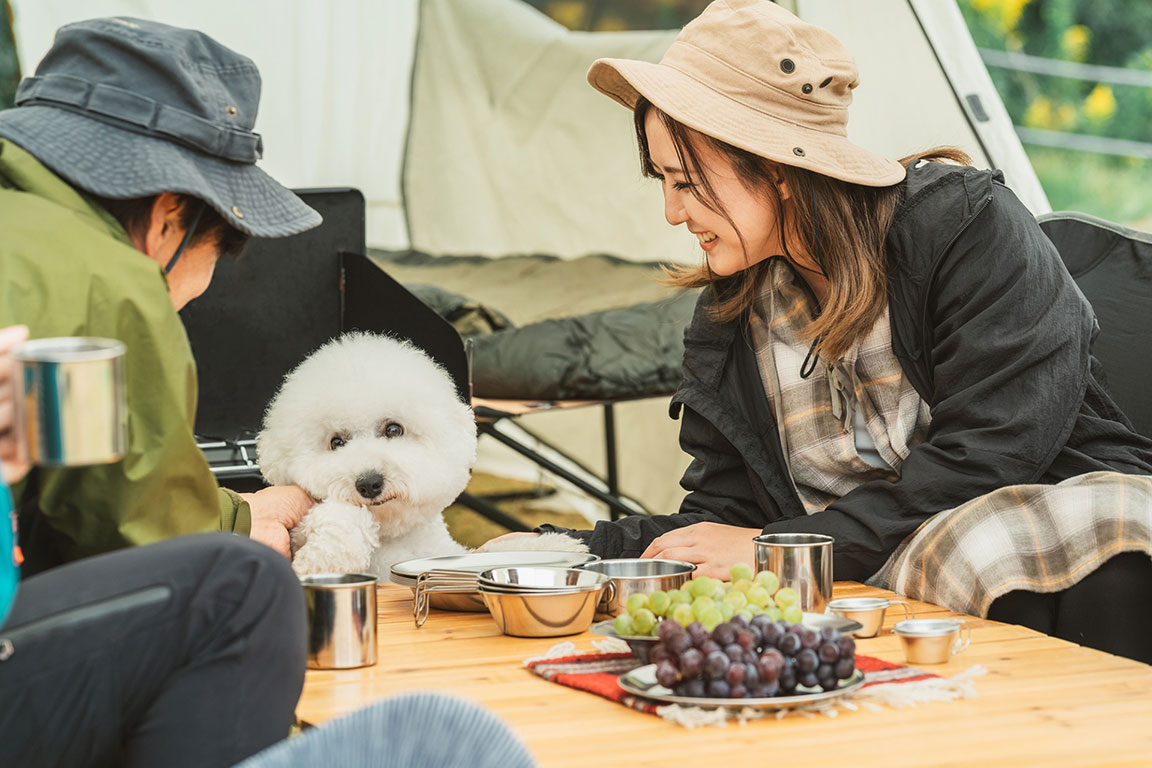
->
[[13, 336, 128, 466]]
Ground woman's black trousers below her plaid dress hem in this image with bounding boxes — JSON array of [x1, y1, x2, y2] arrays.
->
[[988, 552, 1152, 664]]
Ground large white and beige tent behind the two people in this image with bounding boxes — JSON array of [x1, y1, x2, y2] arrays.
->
[[9, 0, 1049, 522]]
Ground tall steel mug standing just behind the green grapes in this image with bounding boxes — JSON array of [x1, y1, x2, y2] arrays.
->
[[752, 533, 835, 614]]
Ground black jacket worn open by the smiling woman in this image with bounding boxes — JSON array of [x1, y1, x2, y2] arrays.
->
[[540, 162, 1152, 580]]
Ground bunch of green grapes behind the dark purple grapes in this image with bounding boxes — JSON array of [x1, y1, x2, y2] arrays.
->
[[613, 563, 804, 637]]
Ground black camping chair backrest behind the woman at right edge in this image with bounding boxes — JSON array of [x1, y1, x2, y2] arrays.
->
[[1037, 212, 1152, 438]]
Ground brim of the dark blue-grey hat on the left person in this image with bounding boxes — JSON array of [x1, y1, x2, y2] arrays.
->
[[0, 106, 323, 237]]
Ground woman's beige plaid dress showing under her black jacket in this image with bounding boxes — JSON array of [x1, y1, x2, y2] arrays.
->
[[753, 260, 1152, 616]]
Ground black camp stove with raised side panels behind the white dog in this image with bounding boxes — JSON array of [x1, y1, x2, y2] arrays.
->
[[181, 189, 469, 465]]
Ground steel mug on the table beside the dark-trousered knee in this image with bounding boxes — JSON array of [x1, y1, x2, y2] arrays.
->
[[300, 573, 378, 669]]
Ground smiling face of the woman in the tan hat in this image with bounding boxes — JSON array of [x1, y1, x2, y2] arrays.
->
[[644, 109, 787, 276]]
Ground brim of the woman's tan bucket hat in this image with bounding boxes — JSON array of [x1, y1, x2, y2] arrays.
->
[[588, 59, 905, 187]]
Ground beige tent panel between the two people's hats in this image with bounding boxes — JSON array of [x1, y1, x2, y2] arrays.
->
[[403, 0, 677, 261]]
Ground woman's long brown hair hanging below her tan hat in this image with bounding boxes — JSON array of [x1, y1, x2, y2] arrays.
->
[[634, 97, 971, 359]]
